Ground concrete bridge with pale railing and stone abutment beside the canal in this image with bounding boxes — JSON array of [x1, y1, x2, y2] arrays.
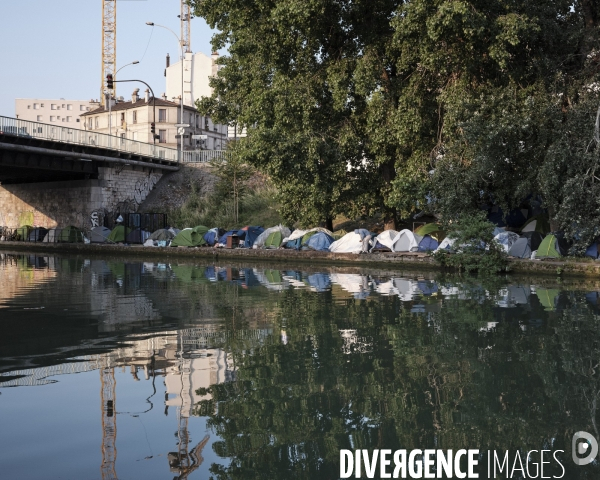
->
[[0, 116, 225, 230]]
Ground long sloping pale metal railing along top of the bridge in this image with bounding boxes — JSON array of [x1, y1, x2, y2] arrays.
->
[[0, 116, 179, 162]]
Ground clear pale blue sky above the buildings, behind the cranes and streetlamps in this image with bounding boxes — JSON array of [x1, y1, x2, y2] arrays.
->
[[0, 0, 219, 117]]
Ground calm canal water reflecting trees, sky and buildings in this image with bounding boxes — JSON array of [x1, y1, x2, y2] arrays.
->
[[0, 254, 600, 480]]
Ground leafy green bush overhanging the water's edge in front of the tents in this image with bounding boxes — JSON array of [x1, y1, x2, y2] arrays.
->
[[433, 212, 508, 275]]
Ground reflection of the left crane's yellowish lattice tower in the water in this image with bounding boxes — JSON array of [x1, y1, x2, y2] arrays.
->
[[100, 365, 117, 480]]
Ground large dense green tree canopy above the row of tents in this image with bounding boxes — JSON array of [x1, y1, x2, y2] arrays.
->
[[191, 0, 600, 240]]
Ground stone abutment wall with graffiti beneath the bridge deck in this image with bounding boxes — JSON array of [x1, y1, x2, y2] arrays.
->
[[0, 166, 162, 231]]
